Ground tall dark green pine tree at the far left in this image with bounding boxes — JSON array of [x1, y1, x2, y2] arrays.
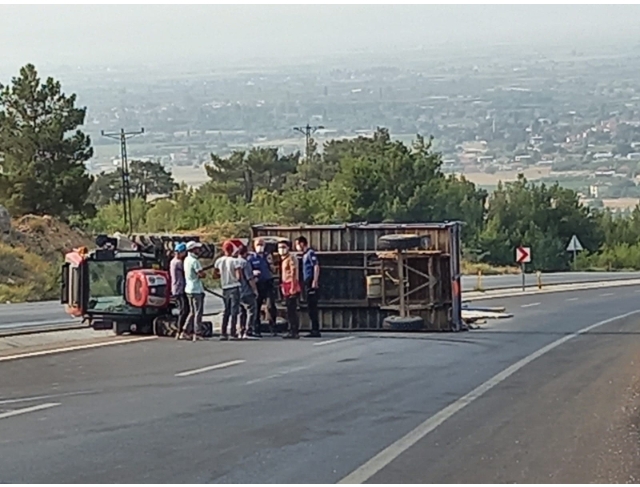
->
[[0, 64, 94, 218]]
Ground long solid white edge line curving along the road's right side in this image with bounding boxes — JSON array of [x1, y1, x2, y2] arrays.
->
[[338, 310, 640, 484]]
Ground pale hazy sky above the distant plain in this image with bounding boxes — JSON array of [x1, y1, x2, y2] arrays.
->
[[0, 5, 640, 72]]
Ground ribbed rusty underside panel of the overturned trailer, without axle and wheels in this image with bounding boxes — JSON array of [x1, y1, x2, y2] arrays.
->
[[252, 222, 462, 331]]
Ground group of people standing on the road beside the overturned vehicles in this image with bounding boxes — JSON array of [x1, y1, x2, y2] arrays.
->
[[169, 236, 321, 341]]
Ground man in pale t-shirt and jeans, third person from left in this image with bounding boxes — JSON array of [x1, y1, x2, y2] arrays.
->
[[214, 241, 242, 341]]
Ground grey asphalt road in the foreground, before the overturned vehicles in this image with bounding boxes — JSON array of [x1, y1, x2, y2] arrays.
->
[[0, 287, 640, 483]]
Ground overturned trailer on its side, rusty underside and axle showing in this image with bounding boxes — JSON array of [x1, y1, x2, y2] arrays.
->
[[251, 222, 465, 331]]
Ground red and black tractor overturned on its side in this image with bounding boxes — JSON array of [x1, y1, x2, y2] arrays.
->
[[61, 234, 215, 334]]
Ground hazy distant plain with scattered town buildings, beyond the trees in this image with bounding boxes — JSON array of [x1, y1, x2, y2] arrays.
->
[[62, 43, 640, 211]]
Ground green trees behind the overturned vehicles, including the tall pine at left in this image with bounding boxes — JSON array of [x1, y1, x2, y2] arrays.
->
[[0, 65, 640, 271]]
